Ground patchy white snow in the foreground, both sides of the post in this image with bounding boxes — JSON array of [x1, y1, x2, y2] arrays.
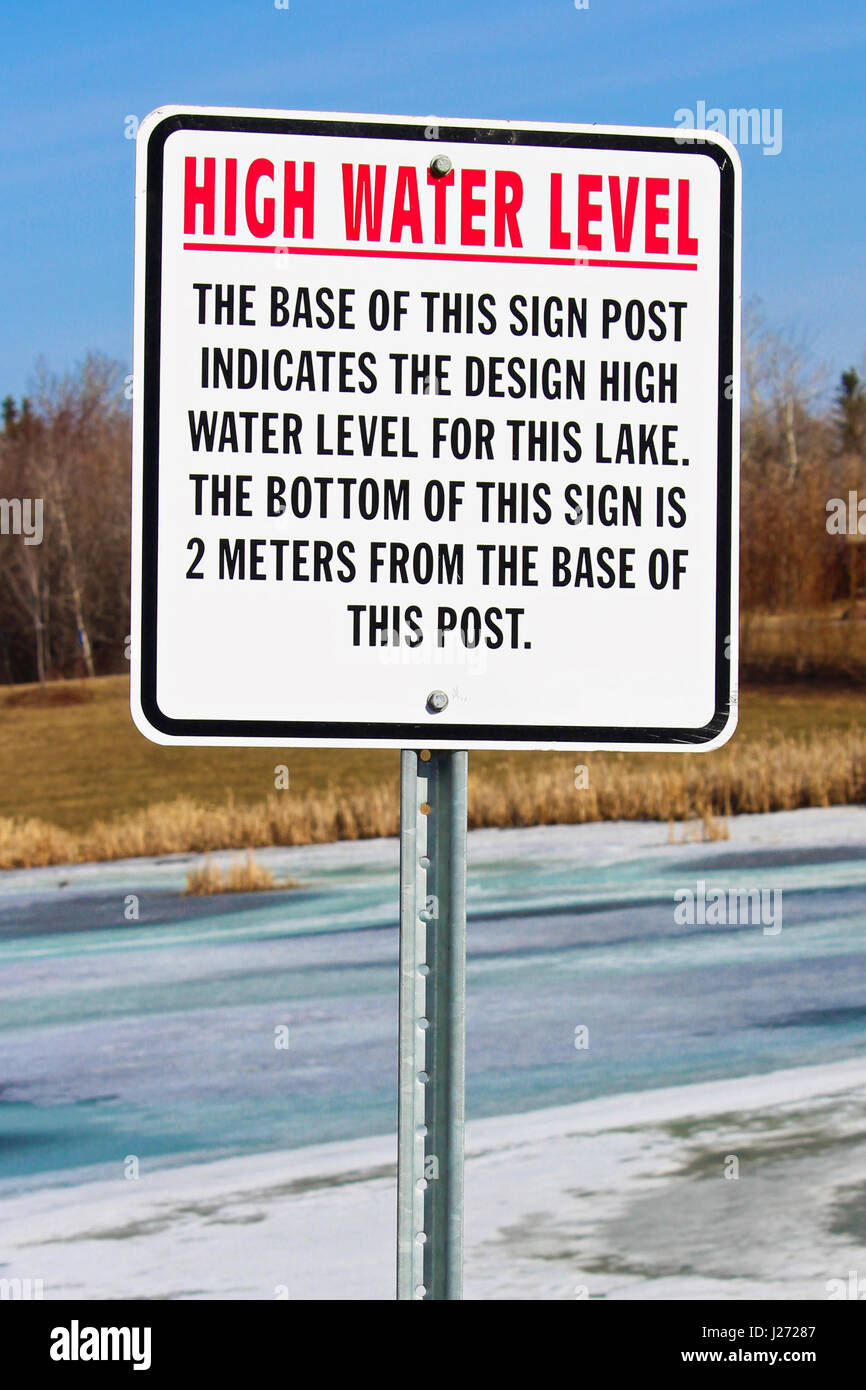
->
[[3, 1061, 866, 1300]]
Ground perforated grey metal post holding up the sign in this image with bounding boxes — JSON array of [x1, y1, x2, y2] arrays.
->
[[398, 749, 468, 1300]]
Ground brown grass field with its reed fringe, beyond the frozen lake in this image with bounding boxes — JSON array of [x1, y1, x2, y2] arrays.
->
[[0, 677, 866, 867]]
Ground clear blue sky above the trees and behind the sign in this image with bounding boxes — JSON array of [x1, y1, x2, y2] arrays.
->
[[0, 0, 866, 395]]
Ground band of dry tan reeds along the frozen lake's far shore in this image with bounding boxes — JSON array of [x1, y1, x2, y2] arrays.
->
[[0, 730, 866, 869]]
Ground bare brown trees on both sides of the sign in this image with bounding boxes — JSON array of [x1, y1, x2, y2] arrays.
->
[[0, 310, 866, 684]]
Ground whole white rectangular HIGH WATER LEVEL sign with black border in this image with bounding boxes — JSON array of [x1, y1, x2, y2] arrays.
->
[[132, 107, 740, 749]]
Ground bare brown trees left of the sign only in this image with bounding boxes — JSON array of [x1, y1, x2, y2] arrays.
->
[[0, 354, 132, 684]]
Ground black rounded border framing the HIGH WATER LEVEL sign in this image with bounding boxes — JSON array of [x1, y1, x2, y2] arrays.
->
[[140, 111, 737, 751]]
